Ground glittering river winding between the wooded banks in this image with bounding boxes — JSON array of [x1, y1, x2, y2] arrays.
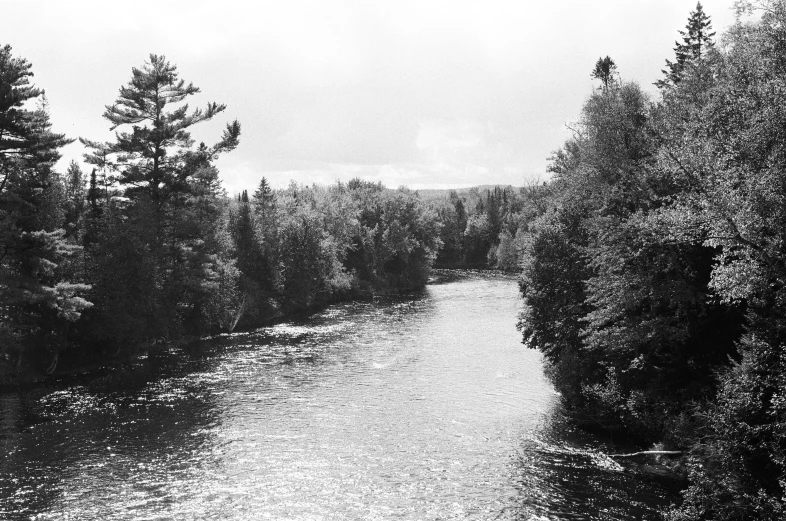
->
[[0, 275, 674, 520]]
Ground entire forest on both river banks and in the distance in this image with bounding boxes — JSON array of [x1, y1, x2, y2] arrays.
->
[[0, 0, 786, 521]]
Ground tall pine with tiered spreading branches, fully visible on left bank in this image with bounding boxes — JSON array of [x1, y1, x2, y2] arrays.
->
[[82, 54, 240, 344]]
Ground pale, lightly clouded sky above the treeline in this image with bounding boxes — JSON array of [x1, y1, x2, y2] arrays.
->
[[6, 0, 734, 193]]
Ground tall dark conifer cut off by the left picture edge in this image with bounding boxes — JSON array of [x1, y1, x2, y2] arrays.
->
[[0, 45, 91, 379]]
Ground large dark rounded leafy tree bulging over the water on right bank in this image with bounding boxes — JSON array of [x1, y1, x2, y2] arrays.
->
[[521, 50, 741, 441]]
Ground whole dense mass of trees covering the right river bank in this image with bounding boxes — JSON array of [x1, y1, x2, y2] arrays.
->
[[520, 0, 786, 520]]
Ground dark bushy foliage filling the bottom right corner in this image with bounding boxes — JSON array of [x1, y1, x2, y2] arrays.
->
[[669, 334, 786, 521]]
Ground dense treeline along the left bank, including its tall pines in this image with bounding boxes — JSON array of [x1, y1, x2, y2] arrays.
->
[[0, 51, 441, 383]]
